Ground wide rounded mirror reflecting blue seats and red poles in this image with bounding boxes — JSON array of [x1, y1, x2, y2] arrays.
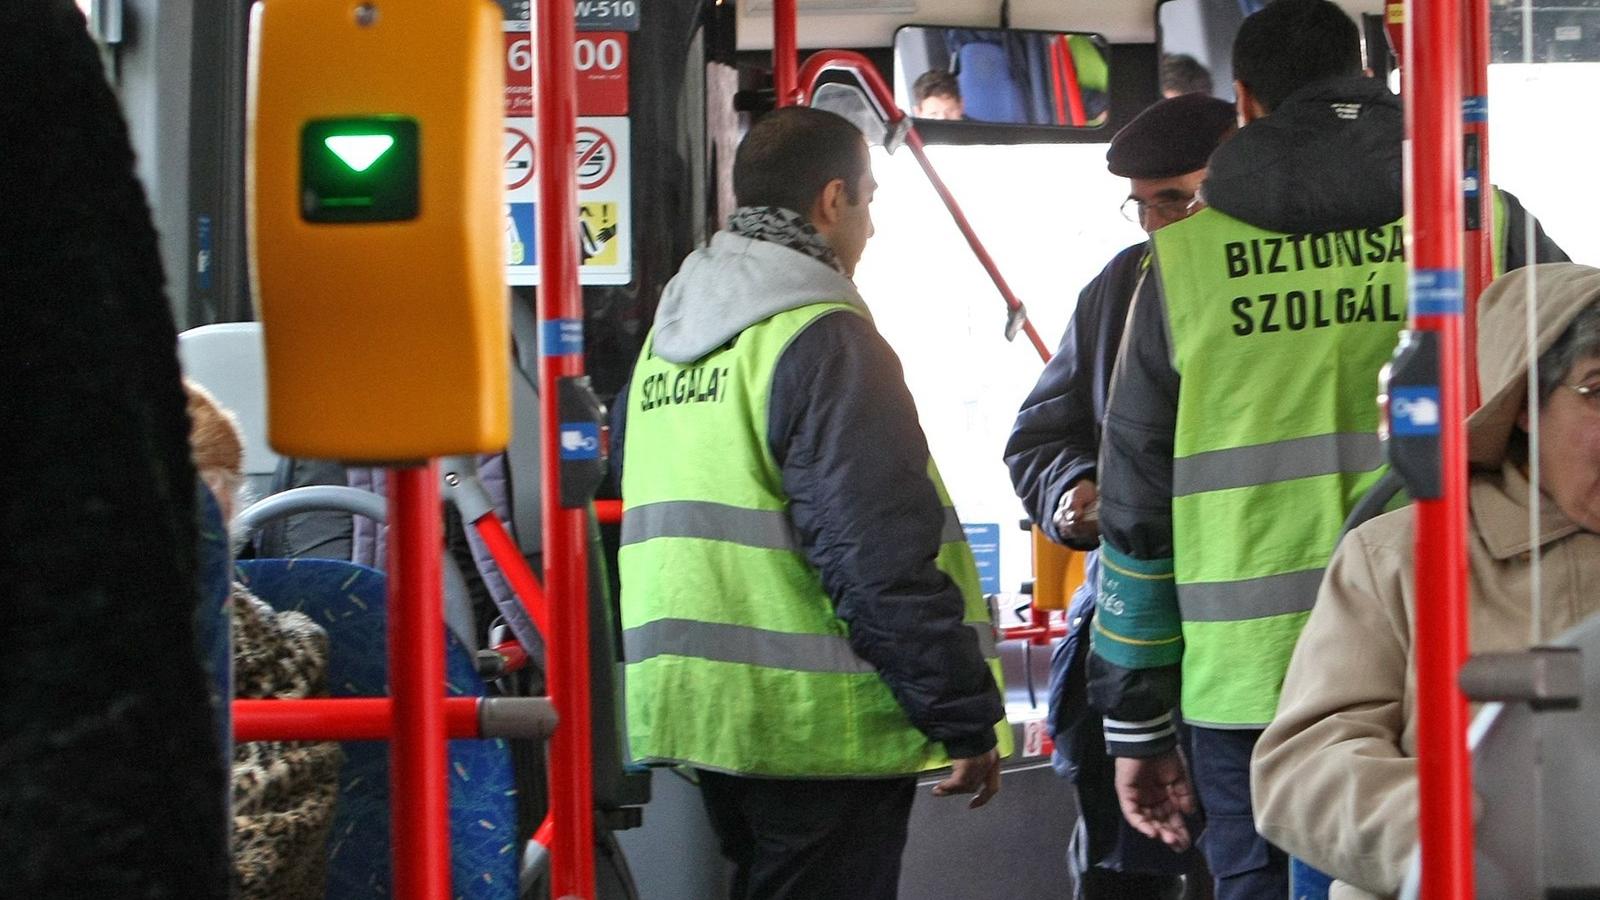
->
[[894, 26, 1110, 128]]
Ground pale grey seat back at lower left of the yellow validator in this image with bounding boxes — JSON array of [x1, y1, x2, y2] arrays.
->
[[178, 322, 278, 493]]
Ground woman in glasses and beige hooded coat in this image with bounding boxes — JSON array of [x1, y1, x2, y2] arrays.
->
[[1251, 263, 1600, 900]]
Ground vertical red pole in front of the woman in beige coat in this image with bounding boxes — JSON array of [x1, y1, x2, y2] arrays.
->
[[1405, 0, 1474, 900]]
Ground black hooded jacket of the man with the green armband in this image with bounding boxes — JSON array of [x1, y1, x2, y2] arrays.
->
[[1090, 78, 1566, 756]]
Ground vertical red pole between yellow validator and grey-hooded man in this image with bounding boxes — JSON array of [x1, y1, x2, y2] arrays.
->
[[533, 0, 595, 883]]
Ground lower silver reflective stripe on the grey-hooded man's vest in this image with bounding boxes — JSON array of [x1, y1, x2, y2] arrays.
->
[[622, 618, 995, 674]]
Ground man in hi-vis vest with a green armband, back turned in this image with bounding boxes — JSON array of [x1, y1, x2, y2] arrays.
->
[[1090, 0, 1565, 900]]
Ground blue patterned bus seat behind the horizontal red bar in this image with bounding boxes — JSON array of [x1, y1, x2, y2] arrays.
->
[[237, 559, 522, 900]]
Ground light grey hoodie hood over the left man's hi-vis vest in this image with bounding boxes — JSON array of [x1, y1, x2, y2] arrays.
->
[[651, 231, 867, 365]]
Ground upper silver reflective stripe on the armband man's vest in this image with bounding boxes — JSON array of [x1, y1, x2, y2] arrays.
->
[[1173, 432, 1384, 496]]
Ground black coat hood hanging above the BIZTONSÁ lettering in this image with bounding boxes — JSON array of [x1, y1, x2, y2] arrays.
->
[[1203, 77, 1405, 234]]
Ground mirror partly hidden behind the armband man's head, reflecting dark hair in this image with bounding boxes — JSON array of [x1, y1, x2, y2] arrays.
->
[[1155, 0, 1266, 102]]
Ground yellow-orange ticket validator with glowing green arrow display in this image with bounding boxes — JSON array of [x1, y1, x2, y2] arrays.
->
[[246, 0, 510, 463]]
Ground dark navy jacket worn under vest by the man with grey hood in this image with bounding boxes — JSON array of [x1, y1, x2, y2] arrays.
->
[[611, 238, 1005, 759]]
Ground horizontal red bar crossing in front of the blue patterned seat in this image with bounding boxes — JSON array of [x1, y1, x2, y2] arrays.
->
[[234, 697, 482, 741]]
